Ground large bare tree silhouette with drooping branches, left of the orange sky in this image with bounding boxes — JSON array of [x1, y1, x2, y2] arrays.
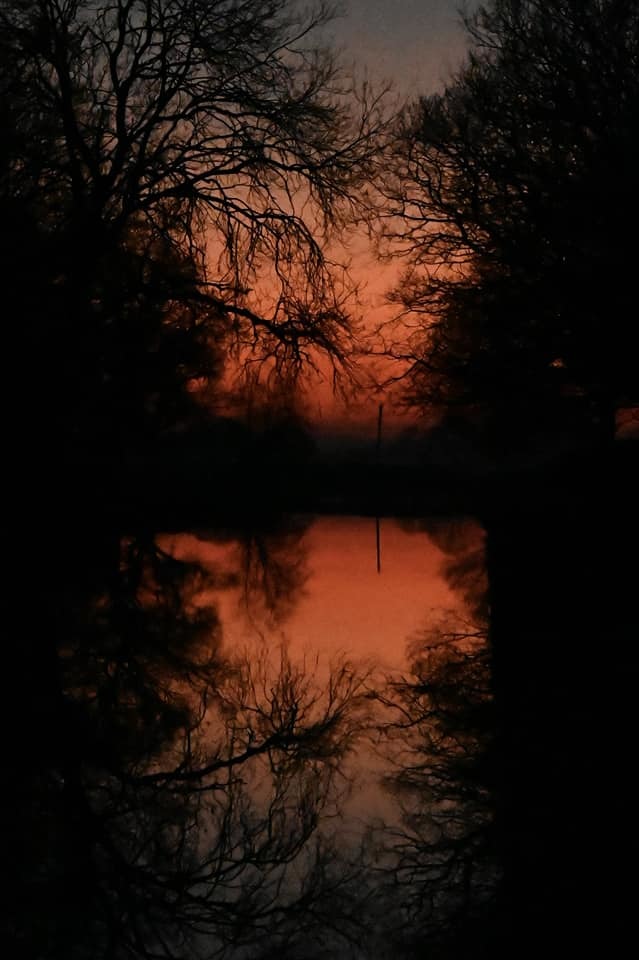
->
[[0, 0, 380, 454]]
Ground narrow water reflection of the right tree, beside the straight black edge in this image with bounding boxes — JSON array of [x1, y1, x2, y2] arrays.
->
[[370, 616, 500, 958]]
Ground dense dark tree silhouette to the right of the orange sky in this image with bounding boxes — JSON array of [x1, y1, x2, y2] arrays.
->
[[388, 0, 639, 450]]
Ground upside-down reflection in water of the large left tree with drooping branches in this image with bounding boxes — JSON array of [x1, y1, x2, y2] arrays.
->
[[5, 537, 376, 958]]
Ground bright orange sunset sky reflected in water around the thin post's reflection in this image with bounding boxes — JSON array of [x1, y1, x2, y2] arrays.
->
[[165, 517, 476, 669]]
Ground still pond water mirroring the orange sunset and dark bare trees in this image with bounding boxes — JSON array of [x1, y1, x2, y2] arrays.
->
[[21, 516, 495, 960]]
